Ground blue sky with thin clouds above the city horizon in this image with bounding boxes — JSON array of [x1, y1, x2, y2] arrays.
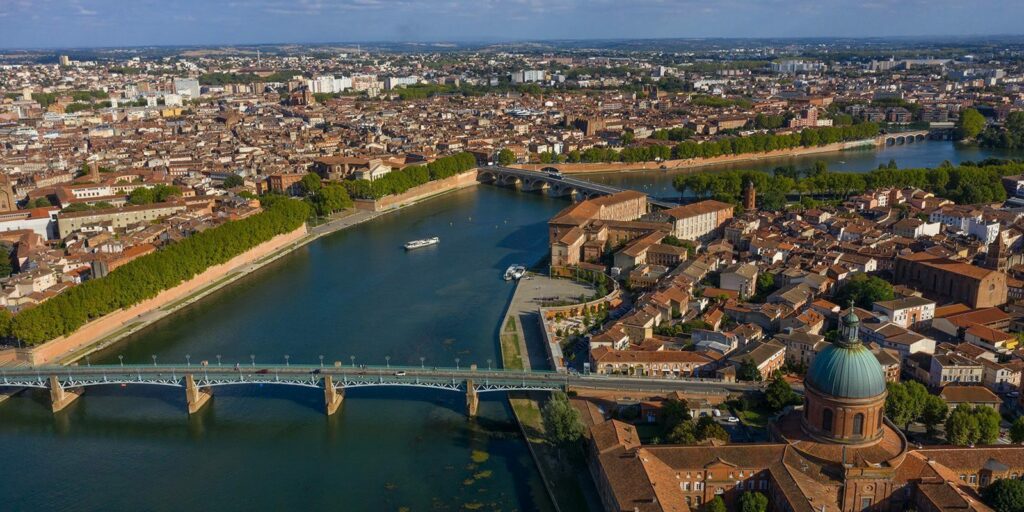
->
[[0, 0, 1024, 48]]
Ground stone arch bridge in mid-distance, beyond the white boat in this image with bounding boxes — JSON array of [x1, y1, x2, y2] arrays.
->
[[477, 166, 679, 208]]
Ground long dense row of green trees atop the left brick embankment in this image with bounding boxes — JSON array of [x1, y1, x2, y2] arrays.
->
[[9, 197, 309, 345]]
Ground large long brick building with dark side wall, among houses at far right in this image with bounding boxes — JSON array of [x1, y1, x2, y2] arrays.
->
[[895, 252, 1008, 307]]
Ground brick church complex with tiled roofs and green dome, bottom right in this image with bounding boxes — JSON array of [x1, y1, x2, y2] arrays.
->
[[589, 309, 1024, 512]]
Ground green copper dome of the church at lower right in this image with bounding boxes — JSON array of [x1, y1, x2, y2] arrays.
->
[[807, 342, 886, 398]]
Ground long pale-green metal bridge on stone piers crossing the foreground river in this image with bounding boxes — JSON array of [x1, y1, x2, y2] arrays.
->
[[0, 361, 758, 417]]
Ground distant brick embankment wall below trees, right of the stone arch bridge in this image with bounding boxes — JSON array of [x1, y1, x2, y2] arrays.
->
[[515, 139, 884, 174]]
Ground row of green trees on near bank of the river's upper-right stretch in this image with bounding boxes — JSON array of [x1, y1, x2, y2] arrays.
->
[[674, 162, 1024, 210]]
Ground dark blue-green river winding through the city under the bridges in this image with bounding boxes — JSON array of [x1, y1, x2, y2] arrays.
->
[[0, 142, 1019, 511]]
